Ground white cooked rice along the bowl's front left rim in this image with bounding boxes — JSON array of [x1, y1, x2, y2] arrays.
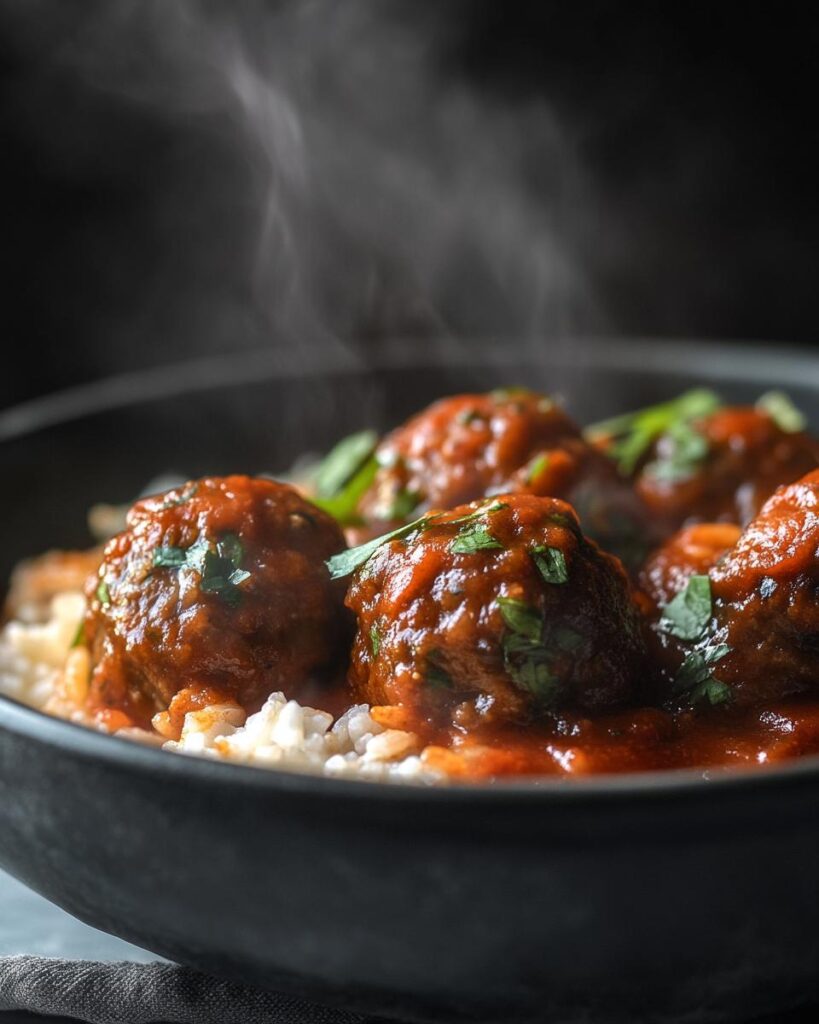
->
[[0, 592, 445, 782]]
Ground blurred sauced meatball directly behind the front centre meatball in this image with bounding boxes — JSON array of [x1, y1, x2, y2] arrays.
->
[[360, 388, 646, 554]]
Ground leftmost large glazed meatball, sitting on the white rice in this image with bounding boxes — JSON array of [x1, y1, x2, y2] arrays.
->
[[85, 476, 350, 731]]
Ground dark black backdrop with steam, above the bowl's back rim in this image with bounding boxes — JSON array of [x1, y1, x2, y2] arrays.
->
[[0, 0, 819, 406]]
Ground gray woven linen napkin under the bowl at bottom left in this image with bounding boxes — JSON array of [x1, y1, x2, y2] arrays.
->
[[0, 956, 375, 1024]]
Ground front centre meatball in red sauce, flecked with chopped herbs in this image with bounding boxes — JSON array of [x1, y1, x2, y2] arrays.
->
[[339, 495, 644, 732]]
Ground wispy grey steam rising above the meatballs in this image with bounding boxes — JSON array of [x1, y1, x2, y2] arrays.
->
[[11, 0, 603, 368]]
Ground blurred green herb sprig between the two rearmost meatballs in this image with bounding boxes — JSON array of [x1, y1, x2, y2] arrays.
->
[[584, 388, 720, 476]]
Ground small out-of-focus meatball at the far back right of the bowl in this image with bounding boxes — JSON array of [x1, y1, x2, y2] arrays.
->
[[635, 408, 819, 532]]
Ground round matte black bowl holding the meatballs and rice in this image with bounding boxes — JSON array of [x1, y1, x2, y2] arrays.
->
[[0, 342, 819, 1022]]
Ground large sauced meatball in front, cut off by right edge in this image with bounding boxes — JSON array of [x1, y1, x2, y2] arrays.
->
[[644, 470, 819, 709]]
